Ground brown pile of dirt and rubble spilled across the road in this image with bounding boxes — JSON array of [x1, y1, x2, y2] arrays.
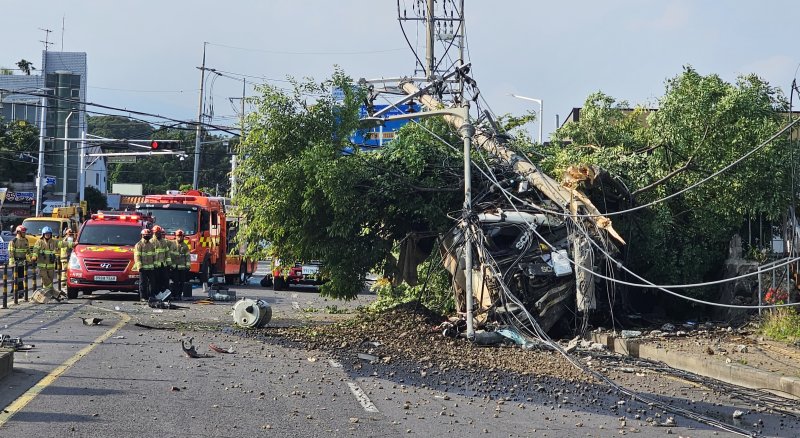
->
[[255, 302, 592, 382]]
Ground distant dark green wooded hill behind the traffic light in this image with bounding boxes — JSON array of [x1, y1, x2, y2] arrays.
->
[[89, 116, 236, 195]]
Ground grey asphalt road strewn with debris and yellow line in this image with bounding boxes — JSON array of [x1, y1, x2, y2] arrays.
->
[[0, 268, 800, 437]]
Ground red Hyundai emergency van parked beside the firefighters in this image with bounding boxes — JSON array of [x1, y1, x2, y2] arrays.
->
[[67, 212, 151, 298]]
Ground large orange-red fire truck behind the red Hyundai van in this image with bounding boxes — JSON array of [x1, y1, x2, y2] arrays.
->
[[136, 190, 255, 283]]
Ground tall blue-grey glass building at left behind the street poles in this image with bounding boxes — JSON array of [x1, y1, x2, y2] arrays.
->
[[0, 51, 107, 213]]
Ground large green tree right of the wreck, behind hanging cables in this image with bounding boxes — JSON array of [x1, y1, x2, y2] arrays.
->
[[541, 67, 797, 295]]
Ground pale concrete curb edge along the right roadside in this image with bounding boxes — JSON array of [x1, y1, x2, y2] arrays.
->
[[592, 333, 800, 398]]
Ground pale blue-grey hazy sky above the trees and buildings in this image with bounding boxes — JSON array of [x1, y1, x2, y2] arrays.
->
[[0, 0, 800, 140]]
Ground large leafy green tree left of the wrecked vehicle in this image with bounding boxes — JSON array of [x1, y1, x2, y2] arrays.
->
[[234, 70, 461, 299]]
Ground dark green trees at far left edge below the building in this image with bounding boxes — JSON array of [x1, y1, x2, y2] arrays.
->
[[0, 119, 39, 182]]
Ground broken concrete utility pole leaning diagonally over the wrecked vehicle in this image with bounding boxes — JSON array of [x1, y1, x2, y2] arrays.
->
[[400, 82, 625, 244]]
